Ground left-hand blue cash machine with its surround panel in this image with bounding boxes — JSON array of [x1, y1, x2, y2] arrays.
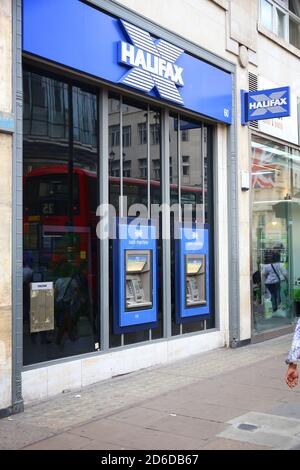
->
[[113, 221, 157, 333]]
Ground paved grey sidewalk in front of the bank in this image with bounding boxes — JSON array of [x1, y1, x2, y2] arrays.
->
[[0, 335, 300, 450]]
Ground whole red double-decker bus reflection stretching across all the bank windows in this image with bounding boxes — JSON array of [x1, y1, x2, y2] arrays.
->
[[24, 165, 202, 277]]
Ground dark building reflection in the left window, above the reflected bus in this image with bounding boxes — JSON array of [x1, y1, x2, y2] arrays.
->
[[23, 72, 97, 171]]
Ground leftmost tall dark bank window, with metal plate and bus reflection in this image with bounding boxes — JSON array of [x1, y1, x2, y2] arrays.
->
[[23, 71, 99, 365]]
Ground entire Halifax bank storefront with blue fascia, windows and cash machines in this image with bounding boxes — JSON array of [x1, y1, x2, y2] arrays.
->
[[14, 0, 239, 401]]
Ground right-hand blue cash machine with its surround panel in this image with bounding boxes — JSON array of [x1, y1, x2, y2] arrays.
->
[[176, 225, 211, 323]]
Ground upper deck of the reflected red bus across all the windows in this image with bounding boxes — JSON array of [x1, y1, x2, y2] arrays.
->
[[24, 165, 202, 227]]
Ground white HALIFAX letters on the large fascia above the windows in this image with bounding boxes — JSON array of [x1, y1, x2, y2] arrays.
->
[[121, 42, 184, 86]]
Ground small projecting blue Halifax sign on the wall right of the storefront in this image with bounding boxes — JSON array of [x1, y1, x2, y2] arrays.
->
[[241, 86, 291, 124]]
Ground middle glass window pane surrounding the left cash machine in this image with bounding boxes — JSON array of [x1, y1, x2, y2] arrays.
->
[[109, 94, 163, 347]]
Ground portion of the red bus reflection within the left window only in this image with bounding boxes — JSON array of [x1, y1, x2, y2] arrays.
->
[[24, 165, 97, 272]]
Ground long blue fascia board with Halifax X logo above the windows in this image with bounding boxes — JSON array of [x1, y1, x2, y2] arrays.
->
[[23, 0, 232, 124]]
